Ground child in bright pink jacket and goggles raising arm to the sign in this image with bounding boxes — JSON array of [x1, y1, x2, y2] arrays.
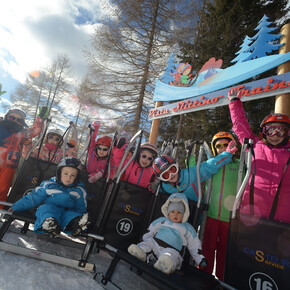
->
[[228, 89, 290, 223]]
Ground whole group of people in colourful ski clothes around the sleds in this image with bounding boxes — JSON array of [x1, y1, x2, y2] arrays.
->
[[0, 90, 290, 280]]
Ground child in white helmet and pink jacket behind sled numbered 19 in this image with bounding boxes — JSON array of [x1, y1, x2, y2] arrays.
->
[[114, 138, 158, 191]]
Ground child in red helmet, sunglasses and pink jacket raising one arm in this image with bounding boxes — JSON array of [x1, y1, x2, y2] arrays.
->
[[87, 121, 115, 183]]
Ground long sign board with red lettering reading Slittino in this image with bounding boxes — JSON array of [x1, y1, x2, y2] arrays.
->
[[148, 72, 290, 120]]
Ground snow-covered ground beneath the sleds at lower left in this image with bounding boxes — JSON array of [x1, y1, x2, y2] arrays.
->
[[0, 222, 157, 290]]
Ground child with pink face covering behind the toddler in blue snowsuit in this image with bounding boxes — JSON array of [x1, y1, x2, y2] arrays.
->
[[22, 128, 76, 164]]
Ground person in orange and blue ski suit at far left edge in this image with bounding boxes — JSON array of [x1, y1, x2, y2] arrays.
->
[[0, 107, 47, 208]]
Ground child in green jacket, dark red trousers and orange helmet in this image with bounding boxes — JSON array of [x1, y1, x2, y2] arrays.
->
[[202, 132, 240, 281]]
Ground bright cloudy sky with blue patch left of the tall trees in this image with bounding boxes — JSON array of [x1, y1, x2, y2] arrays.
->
[[0, 0, 107, 112]]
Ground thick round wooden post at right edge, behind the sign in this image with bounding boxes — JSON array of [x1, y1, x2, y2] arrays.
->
[[275, 23, 290, 116]]
